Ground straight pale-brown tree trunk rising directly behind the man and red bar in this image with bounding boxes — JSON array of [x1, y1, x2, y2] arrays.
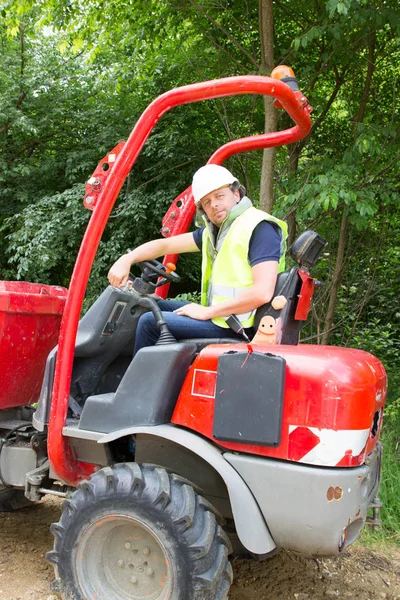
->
[[258, 0, 278, 213]]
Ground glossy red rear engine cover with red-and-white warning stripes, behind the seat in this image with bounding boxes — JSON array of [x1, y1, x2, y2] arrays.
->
[[172, 344, 386, 467]]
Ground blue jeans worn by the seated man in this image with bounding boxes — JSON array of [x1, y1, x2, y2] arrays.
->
[[133, 300, 247, 356]]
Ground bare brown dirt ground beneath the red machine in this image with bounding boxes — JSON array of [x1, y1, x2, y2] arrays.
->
[[0, 498, 400, 600]]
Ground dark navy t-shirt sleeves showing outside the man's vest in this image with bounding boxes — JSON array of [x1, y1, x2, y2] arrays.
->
[[193, 221, 281, 267]]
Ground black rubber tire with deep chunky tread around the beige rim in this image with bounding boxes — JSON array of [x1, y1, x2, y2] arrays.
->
[[47, 463, 232, 600]]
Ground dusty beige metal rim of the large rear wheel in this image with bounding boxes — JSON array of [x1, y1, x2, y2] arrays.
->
[[75, 513, 175, 600]]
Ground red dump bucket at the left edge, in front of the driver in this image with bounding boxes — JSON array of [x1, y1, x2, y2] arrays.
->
[[0, 281, 67, 410]]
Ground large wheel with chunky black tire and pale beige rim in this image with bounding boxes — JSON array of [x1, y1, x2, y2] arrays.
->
[[47, 463, 232, 600]]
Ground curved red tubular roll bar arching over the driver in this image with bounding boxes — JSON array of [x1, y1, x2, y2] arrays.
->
[[48, 75, 311, 485]]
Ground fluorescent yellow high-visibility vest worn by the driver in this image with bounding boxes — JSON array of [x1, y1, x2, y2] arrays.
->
[[201, 207, 287, 329]]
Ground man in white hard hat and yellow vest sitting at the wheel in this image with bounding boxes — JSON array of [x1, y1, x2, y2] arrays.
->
[[108, 165, 287, 354]]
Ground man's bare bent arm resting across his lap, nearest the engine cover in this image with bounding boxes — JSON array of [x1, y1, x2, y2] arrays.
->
[[175, 260, 278, 321]]
